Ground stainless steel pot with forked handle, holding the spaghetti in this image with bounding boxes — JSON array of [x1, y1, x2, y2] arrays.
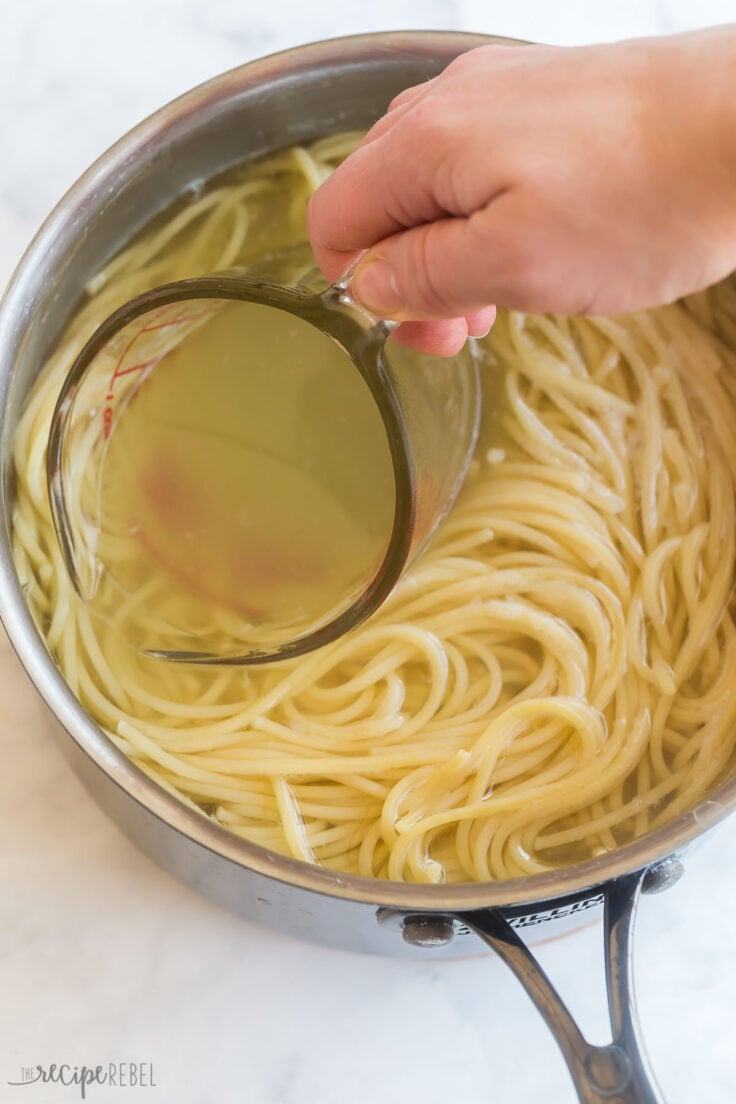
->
[[0, 32, 736, 1104]]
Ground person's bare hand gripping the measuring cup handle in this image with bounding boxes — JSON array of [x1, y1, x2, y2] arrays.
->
[[308, 28, 736, 355]]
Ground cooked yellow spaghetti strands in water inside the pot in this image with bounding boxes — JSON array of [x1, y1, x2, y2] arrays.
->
[[13, 137, 736, 882]]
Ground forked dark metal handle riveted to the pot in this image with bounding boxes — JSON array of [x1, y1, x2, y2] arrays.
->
[[457, 870, 664, 1104]]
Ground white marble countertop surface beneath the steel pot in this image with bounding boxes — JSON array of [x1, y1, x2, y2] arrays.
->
[[0, 0, 736, 1104]]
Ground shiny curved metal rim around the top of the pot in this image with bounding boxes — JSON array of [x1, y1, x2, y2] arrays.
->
[[0, 31, 736, 912]]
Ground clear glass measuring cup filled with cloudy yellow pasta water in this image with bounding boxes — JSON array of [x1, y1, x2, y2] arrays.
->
[[46, 247, 480, 664]]
